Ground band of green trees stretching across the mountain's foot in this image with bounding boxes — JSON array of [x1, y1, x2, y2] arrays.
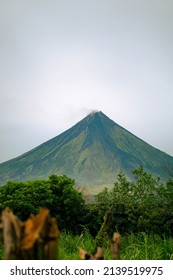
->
[[0, 167, 173, 236]]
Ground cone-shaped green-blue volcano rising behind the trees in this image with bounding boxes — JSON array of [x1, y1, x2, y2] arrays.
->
[[0, 112, 173, 190]]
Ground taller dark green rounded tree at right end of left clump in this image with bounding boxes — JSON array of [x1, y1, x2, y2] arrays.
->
[[49, 175, 85, 233]]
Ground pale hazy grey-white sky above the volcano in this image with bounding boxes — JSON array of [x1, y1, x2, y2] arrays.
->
[[0, 0, 173, 162]]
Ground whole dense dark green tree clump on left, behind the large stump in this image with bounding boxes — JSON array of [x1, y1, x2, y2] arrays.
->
[[0, 175, 84, 233]]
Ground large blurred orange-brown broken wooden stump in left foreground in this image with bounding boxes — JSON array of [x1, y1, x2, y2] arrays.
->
[[0, 208, 60, 260]]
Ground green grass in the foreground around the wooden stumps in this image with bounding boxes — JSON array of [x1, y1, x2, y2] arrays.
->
[[0, 231, 173, 260]]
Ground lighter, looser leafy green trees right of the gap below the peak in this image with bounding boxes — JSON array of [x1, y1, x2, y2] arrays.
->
[[96, 167, 173, 235]]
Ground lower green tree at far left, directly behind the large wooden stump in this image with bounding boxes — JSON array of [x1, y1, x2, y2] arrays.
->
[[0, 180, 52, 220]]
